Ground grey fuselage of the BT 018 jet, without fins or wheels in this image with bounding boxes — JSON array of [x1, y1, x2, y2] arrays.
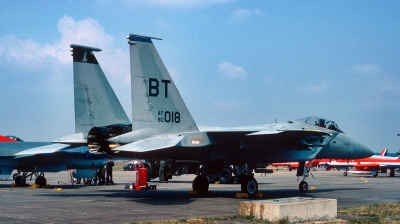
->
[[114, 120, 373, 163]]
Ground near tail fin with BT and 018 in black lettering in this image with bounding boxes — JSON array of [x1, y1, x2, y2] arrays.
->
[[127, 34, 198, 135]]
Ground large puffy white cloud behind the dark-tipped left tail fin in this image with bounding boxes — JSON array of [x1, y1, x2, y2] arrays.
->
[[0, 16, 129, 83]]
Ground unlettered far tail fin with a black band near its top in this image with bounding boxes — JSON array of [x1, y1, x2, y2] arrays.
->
[[70, 44, 130, 133]]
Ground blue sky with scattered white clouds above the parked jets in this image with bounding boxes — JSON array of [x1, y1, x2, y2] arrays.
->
[[0, 0, 400, 152]]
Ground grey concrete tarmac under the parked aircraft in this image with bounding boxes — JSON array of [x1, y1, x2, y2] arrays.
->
[[0, 168, 400, 223]]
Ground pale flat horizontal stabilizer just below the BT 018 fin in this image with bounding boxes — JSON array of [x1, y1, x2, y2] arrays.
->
[[114, 135, 185, 152]]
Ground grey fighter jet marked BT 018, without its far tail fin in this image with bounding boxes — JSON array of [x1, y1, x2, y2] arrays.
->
[[100, 34, 373, 195]]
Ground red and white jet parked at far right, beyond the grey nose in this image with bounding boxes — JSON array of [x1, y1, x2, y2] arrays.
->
[[320, 149, 400, 177]]
